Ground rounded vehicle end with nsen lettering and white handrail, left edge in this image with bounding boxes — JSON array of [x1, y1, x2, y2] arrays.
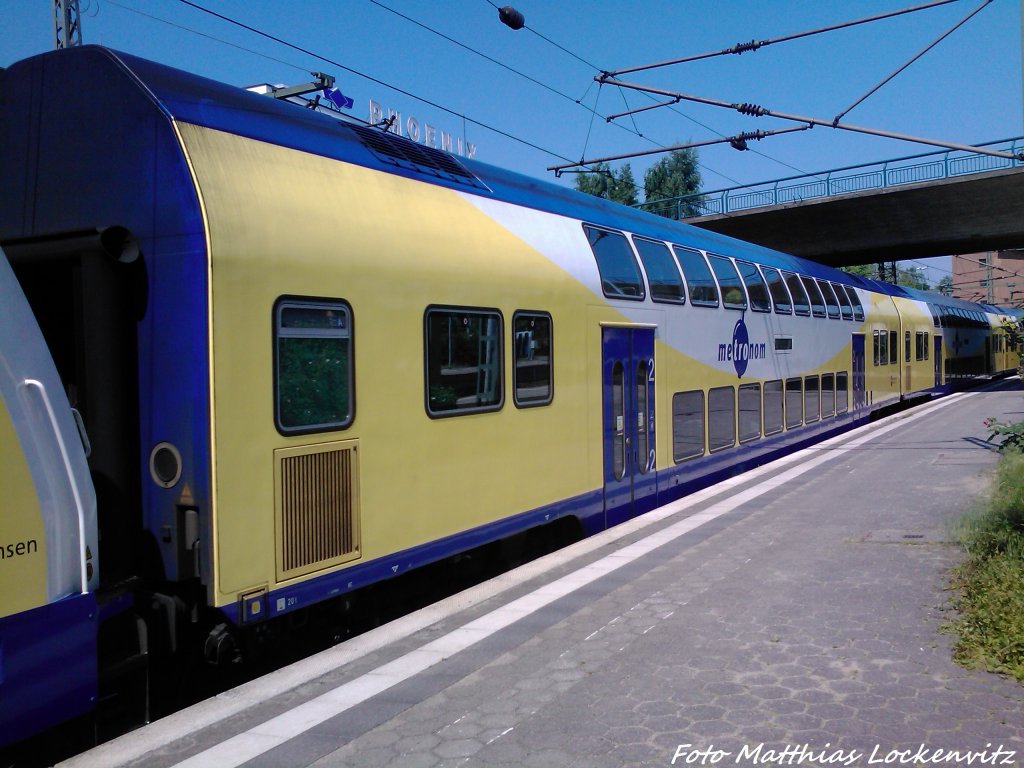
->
[[0, 252, 99, 740]]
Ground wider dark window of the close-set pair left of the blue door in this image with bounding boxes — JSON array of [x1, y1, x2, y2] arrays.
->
[[424, 307, 504, 416]]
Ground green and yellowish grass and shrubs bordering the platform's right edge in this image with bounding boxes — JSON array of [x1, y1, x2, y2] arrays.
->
[[948, 450, 1024, 682]]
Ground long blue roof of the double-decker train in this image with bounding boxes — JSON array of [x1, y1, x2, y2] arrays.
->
[[0, 46, 1019, 319]]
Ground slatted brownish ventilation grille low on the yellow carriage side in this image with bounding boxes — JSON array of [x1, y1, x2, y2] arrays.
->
[[273, 440, 359, 581]]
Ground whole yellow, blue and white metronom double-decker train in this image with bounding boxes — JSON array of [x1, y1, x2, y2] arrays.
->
[[0, 46, 1016, 742]]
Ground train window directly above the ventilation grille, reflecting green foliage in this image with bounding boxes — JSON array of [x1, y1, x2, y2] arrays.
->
[[273, 298, 354, 434]]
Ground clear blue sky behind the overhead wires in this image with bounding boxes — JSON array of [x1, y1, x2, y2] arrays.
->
[[0, 0, 1024, 282]]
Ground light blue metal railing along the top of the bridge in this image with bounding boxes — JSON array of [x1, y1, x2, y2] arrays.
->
[[637, 136, 1024, 219]]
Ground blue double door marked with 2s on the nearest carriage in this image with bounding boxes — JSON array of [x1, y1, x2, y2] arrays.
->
[[601, 328, 657, 525]]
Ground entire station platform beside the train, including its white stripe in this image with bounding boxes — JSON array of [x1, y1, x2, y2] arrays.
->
[[62, 380, 1024, 768]]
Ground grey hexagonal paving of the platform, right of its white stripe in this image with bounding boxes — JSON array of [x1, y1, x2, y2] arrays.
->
[[303, 393, 1024, 768]]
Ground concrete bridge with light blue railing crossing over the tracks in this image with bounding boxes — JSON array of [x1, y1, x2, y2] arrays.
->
[[641, 138, 1024, 266]]
